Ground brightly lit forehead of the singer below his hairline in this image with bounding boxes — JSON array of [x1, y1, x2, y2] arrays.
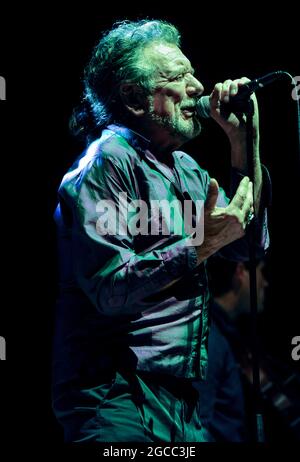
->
[[144, 43, 191, 74]]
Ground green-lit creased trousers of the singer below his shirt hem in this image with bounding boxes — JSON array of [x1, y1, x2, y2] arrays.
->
[[53, 371, 210, 443]]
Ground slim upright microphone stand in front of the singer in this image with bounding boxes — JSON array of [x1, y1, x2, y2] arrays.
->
[[224, 95, 265, 443]]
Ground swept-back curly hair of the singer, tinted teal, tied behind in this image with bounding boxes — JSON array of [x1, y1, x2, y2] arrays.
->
[[70, 19, 180, 143]]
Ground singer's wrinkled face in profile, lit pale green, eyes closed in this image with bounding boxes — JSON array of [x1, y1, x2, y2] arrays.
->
[[144, 44, 204, 148]]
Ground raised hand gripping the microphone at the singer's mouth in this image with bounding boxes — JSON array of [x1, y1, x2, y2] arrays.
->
[[210, 77, 259, 144]]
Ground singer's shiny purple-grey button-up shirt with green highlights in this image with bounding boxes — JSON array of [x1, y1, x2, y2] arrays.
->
[[54, 125, 266, 390]]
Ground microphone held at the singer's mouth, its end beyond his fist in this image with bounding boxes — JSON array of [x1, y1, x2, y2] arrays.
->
[[196, 71, 286, 119]]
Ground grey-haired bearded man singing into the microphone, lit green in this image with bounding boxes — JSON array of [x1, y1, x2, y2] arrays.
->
[[53, 20, 269, 442]]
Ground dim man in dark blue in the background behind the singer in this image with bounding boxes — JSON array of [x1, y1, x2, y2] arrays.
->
[[195, 255, 268, 442]]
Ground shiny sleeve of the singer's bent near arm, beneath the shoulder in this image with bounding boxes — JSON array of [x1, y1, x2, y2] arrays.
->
[[72, 158, 197, 316]]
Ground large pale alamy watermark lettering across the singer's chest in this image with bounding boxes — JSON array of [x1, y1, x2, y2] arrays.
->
[[96, 192, 204, 246]]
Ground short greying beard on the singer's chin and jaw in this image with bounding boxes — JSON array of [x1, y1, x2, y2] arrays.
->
[[148, 100, 202, 144]]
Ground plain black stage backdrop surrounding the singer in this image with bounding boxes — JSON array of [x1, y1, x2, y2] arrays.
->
[[0, 2, 300, 450]]
